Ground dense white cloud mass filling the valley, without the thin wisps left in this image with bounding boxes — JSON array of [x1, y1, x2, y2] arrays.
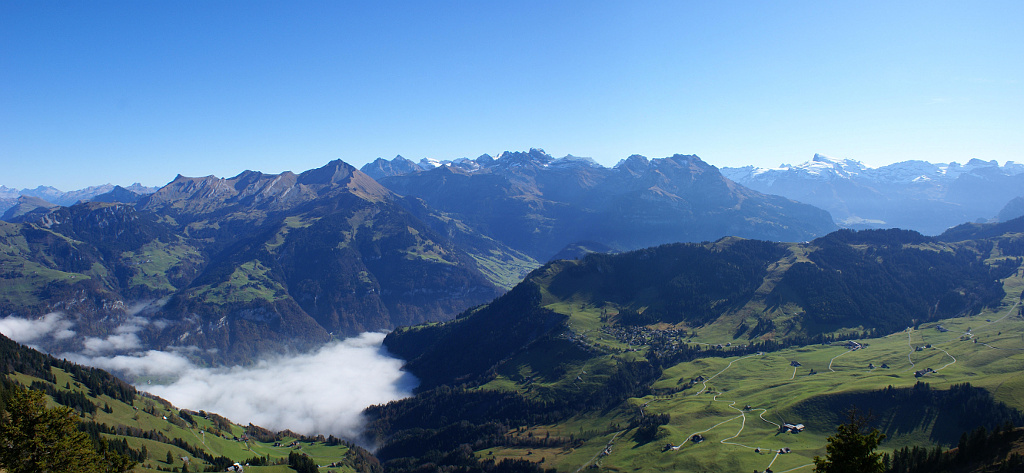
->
[[142, 333, 417, 438]]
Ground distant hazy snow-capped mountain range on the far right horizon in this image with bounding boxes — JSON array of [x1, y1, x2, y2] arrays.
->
[[722, 155, 1024, 234]]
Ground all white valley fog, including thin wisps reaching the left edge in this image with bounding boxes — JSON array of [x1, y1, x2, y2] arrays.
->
[[0, 313, 418, 439]]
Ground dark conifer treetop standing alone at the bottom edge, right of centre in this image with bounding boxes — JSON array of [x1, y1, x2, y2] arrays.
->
[[814, 410, 886, 473]]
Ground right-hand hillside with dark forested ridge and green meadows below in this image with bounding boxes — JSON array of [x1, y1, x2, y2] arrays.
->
[[370, 230, 1024, 472]]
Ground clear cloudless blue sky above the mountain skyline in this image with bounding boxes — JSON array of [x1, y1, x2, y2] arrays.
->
[[0, 0, 1024, 190]]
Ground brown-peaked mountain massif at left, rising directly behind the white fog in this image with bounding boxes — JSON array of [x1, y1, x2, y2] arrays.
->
[[0, 161, 536, 362]]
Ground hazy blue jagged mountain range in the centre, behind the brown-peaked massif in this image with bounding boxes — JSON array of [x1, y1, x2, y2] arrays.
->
[[362, 148, 836, 261]]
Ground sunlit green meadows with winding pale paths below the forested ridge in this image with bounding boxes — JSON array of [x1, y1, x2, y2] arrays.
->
[[477, 273, 1024, 472]]
